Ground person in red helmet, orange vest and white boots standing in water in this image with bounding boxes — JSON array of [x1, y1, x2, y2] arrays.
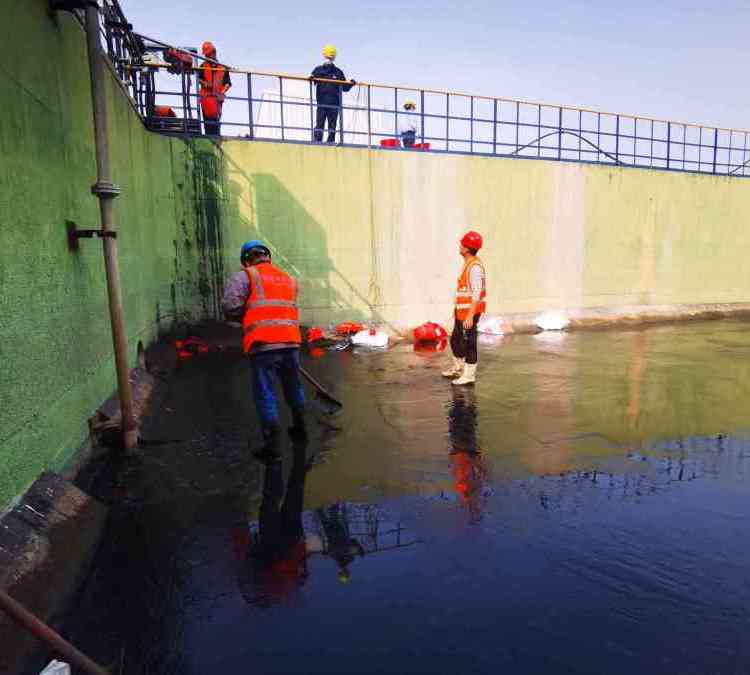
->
[[443, 231, 487, 386]]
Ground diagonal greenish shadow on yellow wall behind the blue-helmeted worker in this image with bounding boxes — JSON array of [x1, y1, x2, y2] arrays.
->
[[224, 156, 402, 332]]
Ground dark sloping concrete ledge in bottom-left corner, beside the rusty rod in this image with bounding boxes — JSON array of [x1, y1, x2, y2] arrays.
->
[[0, 472, 107, 675]]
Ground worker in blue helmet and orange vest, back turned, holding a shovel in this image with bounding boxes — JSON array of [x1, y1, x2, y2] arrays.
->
[[222, 239, 306, 461]]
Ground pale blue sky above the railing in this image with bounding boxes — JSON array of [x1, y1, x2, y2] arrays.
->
[[120, 0, 750, 129]]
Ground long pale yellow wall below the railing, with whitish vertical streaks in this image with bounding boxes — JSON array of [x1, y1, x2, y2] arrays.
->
[[223, 141, 750, 328]]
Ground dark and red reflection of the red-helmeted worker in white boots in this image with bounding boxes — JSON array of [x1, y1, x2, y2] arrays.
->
[[448, 389, 488, 520]]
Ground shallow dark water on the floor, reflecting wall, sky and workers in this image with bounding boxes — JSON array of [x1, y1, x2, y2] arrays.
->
[[63, 322, 750, 675]]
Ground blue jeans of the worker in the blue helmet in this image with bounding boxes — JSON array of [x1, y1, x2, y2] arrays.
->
[[250, 349, 305, 426]]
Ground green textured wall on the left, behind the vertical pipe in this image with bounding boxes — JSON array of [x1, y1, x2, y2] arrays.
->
[[0, 0, 223, 510]]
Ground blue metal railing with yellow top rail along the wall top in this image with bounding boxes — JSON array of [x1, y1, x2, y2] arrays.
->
[[97, 8, 750, 176]]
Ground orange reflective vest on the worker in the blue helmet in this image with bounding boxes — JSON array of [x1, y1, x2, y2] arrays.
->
[[242, 263, 302, 353]]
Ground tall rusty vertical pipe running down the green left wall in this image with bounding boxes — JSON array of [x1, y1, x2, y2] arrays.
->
[[86, 0, 138, 450]]
